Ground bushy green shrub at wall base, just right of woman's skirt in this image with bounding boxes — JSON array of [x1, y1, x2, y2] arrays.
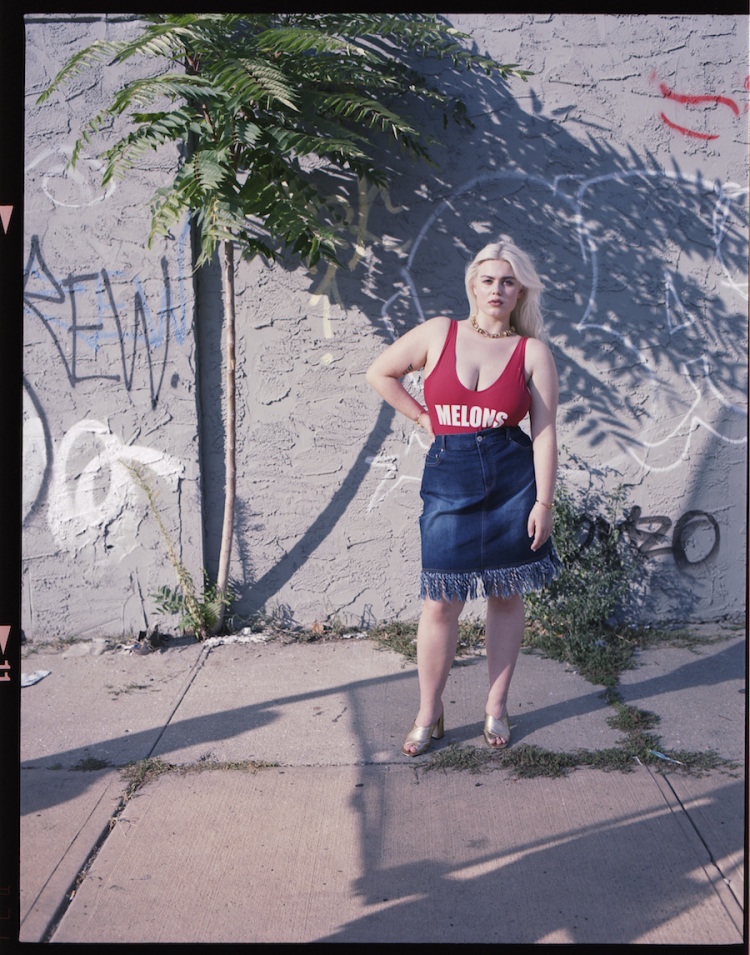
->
[[525, 485, 642, 686]]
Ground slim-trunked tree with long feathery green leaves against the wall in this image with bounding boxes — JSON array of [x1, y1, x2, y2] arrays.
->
[[38, 13, 529, 629]]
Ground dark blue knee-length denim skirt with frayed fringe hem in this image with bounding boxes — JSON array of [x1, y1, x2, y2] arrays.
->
[[419, 427, 561, 601]]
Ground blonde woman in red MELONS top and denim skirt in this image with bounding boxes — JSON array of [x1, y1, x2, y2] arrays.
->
[[367, 241, 560, 756]]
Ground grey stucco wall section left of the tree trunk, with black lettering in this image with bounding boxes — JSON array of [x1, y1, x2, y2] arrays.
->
[[23, 17, 202, 640]]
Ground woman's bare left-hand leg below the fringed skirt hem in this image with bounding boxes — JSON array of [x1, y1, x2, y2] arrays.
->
[[408, 597, 464, 750]]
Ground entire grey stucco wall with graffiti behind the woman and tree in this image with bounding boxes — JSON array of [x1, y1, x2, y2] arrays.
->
[[23, 14, 750, 642]]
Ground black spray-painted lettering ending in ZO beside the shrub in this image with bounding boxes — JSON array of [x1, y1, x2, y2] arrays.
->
[[580, 506, 721, 571]]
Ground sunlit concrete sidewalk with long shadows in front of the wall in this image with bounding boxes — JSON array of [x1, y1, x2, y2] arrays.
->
[[20, 631, 746, 944]]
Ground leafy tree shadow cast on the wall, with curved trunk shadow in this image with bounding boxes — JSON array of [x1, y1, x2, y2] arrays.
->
[[201, 24, 748, 609]]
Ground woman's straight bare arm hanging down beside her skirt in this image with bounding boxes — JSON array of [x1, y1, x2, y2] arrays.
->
[[526, 338, 559, 550]]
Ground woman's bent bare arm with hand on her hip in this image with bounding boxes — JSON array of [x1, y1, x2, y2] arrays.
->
[[367, 318, 447, 437]]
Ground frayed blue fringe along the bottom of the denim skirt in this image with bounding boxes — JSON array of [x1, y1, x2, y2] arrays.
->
[[419, 549, 562, 601]]
